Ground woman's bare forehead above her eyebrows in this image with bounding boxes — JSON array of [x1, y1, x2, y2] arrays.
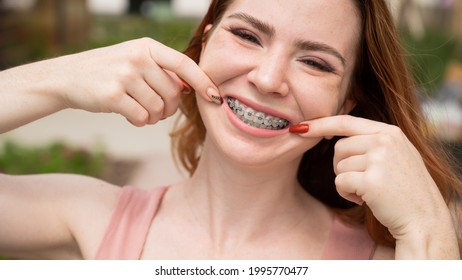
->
[[222, 0, 361, 64]]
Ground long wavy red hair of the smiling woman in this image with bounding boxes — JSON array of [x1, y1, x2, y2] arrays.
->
[[171, 0, 462, 251]]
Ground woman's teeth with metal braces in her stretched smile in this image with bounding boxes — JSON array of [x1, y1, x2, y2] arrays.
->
[[227, 96, 289, 130]]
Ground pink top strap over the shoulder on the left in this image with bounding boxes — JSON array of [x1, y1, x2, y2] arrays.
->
[[96, 186, 167, 260]]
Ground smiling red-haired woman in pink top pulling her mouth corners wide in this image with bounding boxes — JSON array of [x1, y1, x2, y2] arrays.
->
[[0, 0, 462, 259]]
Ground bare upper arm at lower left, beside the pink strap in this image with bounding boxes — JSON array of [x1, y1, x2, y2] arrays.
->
[[0, 174, 120, 259]]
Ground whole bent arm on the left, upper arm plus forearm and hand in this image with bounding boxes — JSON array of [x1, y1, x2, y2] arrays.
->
[[0, 38, 222, 259]]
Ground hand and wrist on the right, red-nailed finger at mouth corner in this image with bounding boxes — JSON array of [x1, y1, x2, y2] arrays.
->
[[292, 115, 460, 259]]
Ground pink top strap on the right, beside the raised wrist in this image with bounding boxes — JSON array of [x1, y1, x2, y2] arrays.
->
[[322, 215, 376, 260]]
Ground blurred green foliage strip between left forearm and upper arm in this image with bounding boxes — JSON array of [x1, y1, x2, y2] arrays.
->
[[0, 141, 107, 177]]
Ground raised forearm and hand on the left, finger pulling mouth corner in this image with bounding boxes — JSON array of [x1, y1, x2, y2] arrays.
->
[[0, 38, 218, 133]]
